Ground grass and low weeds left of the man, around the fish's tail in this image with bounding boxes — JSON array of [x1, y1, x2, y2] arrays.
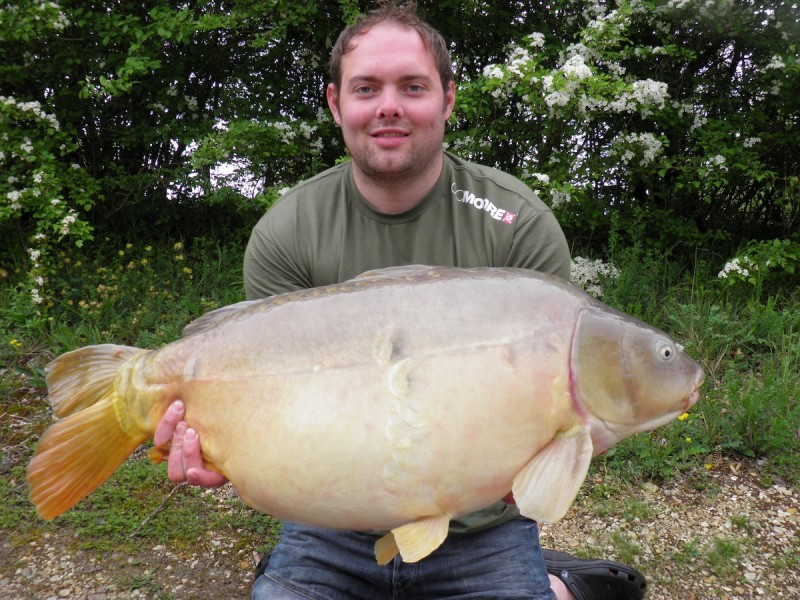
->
[[0, 233, 280, 556]]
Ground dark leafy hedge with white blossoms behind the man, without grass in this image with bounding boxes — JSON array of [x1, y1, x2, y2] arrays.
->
[[0, 0, 800, 312]]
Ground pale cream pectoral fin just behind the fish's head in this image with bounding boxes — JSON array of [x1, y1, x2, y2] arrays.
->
[[511, 425, 592, 523]]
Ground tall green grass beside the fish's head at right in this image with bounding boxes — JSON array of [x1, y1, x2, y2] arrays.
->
[[600, 241, 800, 485]]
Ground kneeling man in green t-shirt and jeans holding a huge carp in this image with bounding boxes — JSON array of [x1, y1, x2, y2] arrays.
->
[[155, 5, 644, 600]]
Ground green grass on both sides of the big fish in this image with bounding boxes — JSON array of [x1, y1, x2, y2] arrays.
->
[[0, 233, 800, 556]]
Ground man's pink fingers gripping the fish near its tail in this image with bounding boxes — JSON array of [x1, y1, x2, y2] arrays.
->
[[153, 400, 228, 488]]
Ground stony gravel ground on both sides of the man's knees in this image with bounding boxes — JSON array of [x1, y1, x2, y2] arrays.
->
[[0, 458, 800, 600]]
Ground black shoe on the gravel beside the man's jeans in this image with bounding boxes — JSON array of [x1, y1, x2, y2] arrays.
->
[[542, 549, 647, 600]]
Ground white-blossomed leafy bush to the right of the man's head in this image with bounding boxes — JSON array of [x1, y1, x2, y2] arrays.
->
[[459, 0, 800, 249]]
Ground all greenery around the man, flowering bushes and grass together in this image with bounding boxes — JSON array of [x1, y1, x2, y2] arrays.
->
[[0, 0, 800, 589]]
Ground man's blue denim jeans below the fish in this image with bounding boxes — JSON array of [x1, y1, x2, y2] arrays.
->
[[252, 518, 555, 600]]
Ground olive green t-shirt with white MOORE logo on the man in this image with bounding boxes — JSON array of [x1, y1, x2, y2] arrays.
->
[[244, 153, 570, 533]]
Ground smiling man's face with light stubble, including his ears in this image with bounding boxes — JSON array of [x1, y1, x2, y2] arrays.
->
[[328, 23, 455, 181]]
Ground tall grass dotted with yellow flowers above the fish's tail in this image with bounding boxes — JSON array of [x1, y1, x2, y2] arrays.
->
[[0, 232, 246, 354]]
